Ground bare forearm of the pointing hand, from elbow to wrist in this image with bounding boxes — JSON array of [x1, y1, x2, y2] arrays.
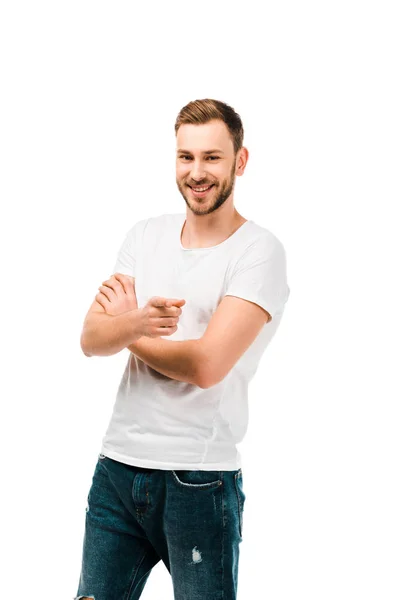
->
[[81, 310, 141, 356]]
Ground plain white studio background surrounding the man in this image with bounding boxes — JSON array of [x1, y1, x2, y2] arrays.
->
[[0, 0, 400, 600]]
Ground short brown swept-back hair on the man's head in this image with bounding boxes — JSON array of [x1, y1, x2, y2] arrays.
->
[[175, 98, 244, 156]]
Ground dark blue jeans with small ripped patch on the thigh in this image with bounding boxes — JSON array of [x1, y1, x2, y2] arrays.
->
[[75, 454, 246, 600]]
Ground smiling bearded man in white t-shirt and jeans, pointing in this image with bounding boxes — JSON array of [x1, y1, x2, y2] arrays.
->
[[73, 99, 290, 600]]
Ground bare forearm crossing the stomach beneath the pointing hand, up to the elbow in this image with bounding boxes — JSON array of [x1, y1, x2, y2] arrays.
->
[[128, 336, 202, 385]]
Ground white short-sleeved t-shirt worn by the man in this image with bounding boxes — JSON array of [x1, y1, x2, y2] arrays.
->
[[101, 213, 290, 471]]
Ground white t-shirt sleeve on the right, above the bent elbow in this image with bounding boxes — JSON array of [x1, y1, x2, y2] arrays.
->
[[225, 236, 290, 318]]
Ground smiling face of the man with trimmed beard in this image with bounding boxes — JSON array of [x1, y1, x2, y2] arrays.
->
[[176, 120, 242, 215]]
